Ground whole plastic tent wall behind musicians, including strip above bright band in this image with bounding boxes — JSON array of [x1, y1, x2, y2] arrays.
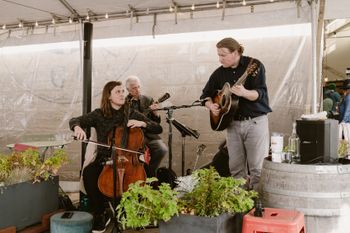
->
[[0, 3, 312, 180]]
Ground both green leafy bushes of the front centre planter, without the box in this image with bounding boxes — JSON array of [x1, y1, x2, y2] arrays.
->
[[117, 168, 258, 229]]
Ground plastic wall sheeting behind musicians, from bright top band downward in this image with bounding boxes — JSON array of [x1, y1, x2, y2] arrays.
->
[[0, 24, 311, 178]]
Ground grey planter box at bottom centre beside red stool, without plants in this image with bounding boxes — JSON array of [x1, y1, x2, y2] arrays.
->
[[159, 214, 243, 233]]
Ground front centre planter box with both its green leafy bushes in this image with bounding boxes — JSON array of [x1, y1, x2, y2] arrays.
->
[[117, 168, 257, 233]]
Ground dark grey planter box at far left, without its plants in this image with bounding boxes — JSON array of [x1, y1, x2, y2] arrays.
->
[[0, 176, 58, 231]]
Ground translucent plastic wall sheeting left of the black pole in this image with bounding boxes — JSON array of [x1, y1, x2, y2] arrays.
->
[[0, 31, 82, 176]]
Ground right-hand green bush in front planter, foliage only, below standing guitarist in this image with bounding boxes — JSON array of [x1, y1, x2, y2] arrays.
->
[[179, 167, 258, 217]]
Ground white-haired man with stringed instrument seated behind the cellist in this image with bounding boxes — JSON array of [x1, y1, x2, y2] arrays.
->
[[125, 76, 170, 177]]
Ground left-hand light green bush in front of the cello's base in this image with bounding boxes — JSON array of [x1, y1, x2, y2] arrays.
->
[[117, 178, 178, 229]]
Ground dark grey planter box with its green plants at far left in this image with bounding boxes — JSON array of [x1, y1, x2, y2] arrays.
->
[[0, 149, 68, 230]]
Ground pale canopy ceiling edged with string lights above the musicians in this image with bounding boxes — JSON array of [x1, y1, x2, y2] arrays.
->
[[0, 0, 290, 30]]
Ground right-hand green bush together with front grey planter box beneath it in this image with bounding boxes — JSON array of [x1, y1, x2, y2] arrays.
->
[[160, 167, 257, 233]]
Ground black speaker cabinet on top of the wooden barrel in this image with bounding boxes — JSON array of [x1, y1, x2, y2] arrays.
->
[[297, 119, 338, 164]]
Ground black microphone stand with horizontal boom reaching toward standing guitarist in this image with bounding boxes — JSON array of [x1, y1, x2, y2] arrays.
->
[[155, 101, 203, 173]]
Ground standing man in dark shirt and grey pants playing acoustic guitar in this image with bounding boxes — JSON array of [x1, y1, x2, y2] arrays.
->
[[200, 38, 272, 190]]
